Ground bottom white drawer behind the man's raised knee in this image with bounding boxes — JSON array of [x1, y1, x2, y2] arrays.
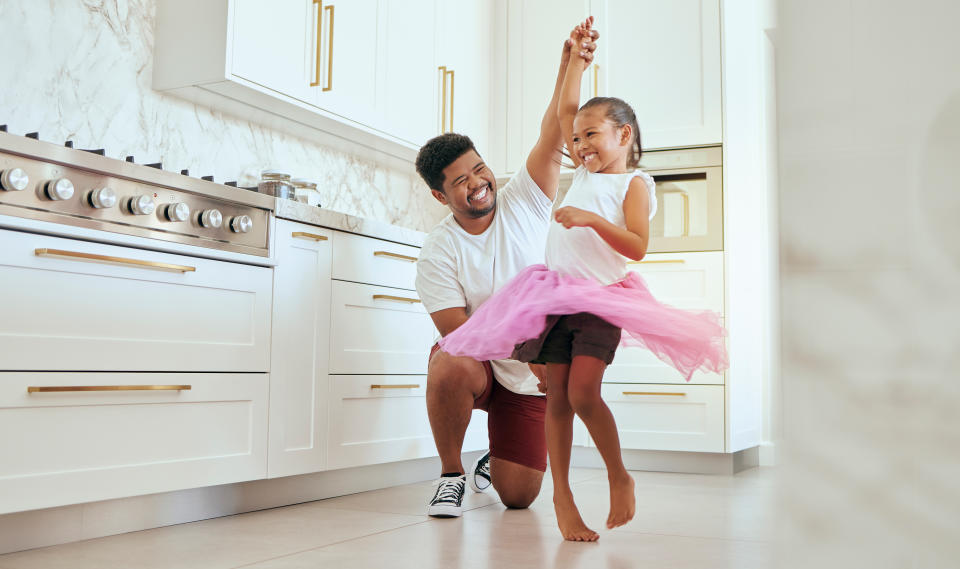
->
[[327, 375, 487, 469]]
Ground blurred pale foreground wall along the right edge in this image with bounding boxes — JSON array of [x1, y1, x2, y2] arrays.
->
[[776, 0, 960, 569]]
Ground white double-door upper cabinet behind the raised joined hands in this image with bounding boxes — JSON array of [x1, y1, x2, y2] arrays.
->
[[495, 0, 723, 173]]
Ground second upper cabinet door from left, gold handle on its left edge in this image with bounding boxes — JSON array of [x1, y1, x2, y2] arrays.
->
[[311, 0, 382, 125]]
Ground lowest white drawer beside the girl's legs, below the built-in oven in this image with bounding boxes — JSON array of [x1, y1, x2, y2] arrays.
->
[[601, 383, 724, 452]]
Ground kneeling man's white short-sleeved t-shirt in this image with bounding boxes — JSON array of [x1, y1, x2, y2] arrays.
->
[[417, 168, 553, 395]]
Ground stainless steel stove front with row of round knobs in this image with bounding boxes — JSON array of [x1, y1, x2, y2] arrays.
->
[[0, 126, 275, 257]]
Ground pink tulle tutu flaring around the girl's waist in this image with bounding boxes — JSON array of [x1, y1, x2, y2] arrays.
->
[[440, 265, 728, 381]]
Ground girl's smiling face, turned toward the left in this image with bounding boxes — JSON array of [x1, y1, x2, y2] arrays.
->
[[572, 106, 633, 174]]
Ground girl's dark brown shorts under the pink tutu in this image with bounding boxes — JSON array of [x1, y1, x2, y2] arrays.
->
[[511, 312, 620, 365]]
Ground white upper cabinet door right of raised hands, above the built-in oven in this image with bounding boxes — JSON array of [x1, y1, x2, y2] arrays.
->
[[592, 0, 723, 148]]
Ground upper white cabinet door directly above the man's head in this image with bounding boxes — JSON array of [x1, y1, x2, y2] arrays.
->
[[433, 0, 498, 155]]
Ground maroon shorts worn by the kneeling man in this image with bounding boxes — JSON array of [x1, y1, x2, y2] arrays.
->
[[430, 345, 547, 472]]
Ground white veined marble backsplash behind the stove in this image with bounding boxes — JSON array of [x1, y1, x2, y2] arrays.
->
[[0, 0, 448, 231]]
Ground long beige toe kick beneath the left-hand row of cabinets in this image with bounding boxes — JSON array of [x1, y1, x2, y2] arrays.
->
[[0, 451, 484, 554]]
